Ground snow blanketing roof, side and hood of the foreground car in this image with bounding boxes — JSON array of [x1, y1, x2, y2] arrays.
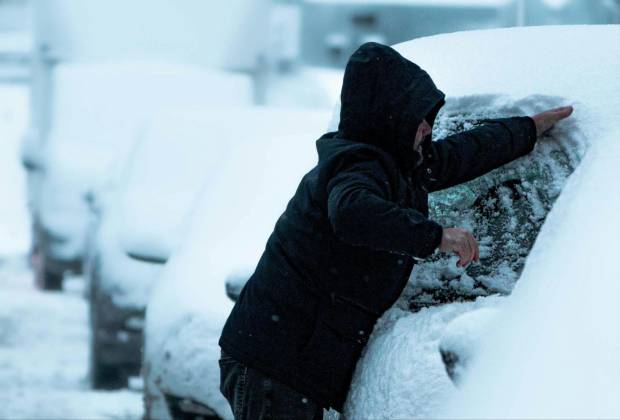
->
[[347, 26, 620, 418]]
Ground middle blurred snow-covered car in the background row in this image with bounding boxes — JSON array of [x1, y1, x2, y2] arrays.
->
[[86, 107, 326, 388]]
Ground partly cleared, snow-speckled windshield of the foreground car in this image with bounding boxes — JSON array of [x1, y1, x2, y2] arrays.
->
[[404, 96, 585, 311]]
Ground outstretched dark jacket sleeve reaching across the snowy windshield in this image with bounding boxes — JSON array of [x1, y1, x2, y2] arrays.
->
[[425, 117, 536, 192]]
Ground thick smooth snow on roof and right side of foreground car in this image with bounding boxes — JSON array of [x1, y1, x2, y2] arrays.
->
[[397, 25, 620, 418]]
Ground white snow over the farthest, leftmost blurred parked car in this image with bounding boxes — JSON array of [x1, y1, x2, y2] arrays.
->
[[40, 61, 252, 234]]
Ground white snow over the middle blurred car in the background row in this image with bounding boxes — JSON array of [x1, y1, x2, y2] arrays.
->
[[120, 107, 325, 262]]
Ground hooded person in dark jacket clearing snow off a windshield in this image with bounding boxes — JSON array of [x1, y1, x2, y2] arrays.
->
[[219, 43, 572, 419]]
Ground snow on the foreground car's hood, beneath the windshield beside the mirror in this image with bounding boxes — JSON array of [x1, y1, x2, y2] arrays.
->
[[346, 297, 501, 419]]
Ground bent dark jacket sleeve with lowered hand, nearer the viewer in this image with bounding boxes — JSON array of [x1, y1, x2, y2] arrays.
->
[[327, 155, 443, 258]]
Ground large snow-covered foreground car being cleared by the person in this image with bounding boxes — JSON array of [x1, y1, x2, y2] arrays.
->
[[345, 25, 620, 418]]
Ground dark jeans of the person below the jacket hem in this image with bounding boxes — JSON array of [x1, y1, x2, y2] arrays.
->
[[220, 352, 323, 420]]
